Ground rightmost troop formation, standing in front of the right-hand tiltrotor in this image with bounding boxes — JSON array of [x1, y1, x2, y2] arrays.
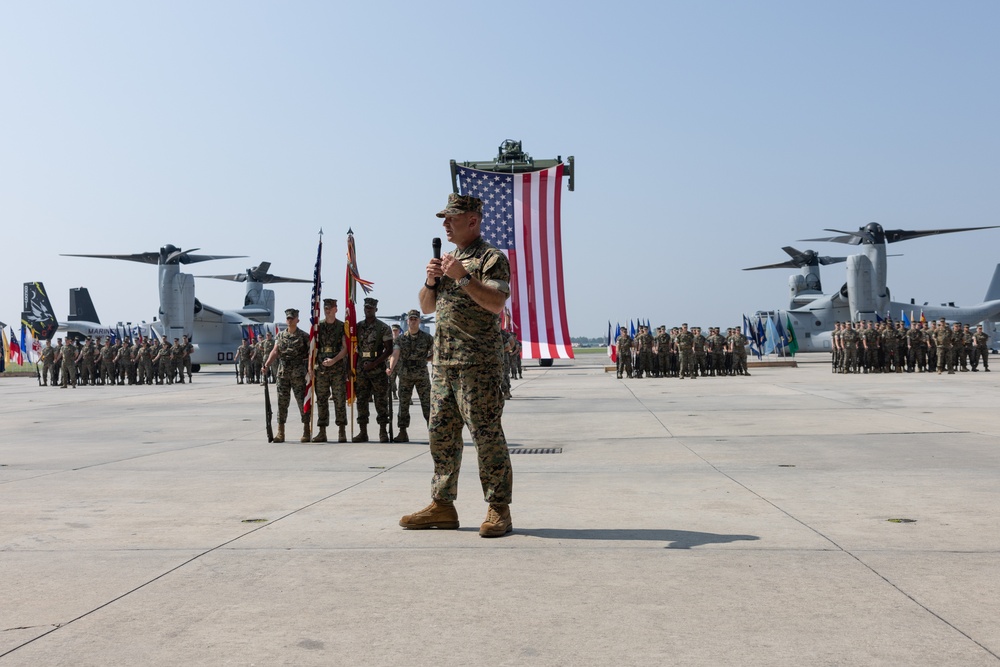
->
[[831, 318, 990, 375]]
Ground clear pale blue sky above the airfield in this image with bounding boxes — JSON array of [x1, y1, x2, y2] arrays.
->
[[0, 1, 1000, 336]]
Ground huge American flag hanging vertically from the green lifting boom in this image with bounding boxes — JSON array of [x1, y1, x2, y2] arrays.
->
[[458, 164, 573, 359]]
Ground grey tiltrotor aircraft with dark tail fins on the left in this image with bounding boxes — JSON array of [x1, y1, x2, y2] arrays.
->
[[24, 245, 311, 371]]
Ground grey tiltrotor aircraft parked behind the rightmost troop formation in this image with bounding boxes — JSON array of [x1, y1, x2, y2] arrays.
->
[[744, 222, 1000, 352]]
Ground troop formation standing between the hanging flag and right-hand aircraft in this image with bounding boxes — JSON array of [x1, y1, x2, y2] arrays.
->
[[615, 323, 750, 379]]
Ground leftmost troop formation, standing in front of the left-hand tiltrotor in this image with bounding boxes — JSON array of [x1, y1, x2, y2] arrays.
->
[[38, 336, 194, 389]]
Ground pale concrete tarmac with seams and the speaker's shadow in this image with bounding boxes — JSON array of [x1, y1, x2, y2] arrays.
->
[[0, 355, 1000, 667]]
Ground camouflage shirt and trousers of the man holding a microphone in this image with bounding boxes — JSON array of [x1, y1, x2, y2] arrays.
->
[[428, 237, 514, 505]]
